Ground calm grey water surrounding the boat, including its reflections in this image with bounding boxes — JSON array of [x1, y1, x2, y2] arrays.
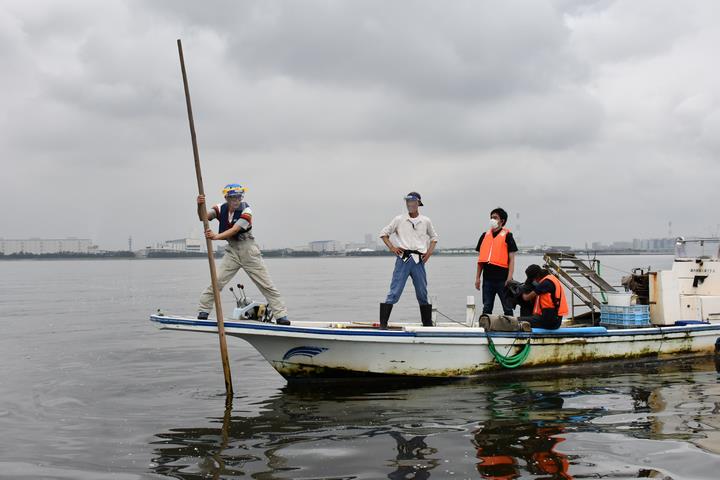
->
[[0, 257, 720, 479]]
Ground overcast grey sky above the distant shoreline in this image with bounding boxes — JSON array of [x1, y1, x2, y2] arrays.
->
[[0, 0, 720, 248]]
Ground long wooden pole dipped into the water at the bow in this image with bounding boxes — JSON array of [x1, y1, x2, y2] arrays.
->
[[178, 39, 233, 397]]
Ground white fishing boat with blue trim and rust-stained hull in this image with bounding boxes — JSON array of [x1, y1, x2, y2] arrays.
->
[[150, 239, 720, 379]]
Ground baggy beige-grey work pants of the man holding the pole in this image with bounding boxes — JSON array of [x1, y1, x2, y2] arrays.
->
[[198, 239, 287, 319]]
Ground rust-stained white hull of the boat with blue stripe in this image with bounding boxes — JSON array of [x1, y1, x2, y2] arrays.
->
[[151, 315, 720, 379]]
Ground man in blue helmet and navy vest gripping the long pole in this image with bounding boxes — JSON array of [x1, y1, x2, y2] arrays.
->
[[197, 183, 290, 325]]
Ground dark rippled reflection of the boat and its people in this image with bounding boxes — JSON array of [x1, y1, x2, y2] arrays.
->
[[151, 360, 720, 479]]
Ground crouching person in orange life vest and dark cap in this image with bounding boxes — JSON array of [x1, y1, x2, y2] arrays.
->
[[520, 264, 568, 330]]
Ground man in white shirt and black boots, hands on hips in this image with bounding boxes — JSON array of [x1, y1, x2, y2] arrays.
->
[[380, 192, 438, 329]]
